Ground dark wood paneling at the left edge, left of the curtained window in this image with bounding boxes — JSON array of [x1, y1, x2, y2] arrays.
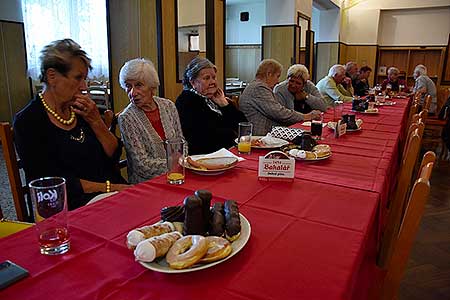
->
[[0, 21, 31, 122]]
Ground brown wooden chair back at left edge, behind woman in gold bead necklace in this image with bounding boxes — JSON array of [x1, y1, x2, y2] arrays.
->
[[0, 122, 33, 222]]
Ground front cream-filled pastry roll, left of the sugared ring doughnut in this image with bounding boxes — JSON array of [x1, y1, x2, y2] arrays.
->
[[134, 231, 182, 262]]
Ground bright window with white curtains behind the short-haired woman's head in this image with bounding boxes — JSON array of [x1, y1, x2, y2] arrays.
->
[[22, 0, 109, 80]]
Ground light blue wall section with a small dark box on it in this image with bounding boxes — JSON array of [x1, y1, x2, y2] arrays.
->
[[226, 2, 266, 45]]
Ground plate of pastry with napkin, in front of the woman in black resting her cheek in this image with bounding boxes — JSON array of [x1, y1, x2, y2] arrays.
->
[[182, 155, 238, 175]]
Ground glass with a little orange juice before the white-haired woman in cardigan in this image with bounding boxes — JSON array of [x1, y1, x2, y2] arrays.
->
[[164, 138, 186, 184]]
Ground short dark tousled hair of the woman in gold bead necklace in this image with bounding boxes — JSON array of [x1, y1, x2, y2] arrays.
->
[[39, 39, 92, 83]]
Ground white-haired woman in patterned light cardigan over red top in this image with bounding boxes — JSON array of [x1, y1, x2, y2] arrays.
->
[[118, 58, 183, 183]]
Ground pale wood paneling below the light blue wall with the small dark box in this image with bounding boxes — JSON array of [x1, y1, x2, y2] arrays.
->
[[225, 45, 261, 82]]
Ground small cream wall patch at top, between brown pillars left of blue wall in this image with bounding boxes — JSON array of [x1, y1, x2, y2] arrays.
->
[[178, 0, 206, 26]]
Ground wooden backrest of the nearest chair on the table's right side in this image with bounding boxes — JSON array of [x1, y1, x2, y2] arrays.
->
[[379, 157, 434, 300]]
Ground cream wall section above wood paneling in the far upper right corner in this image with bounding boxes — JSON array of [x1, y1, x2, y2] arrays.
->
[[378, 7, 450, 46]]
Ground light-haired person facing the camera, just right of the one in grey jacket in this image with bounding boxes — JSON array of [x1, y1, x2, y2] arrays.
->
[[274, 64, 327, 114]]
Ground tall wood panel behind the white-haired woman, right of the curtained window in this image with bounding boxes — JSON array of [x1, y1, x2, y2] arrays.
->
[[109, 0, 158, 112]]
